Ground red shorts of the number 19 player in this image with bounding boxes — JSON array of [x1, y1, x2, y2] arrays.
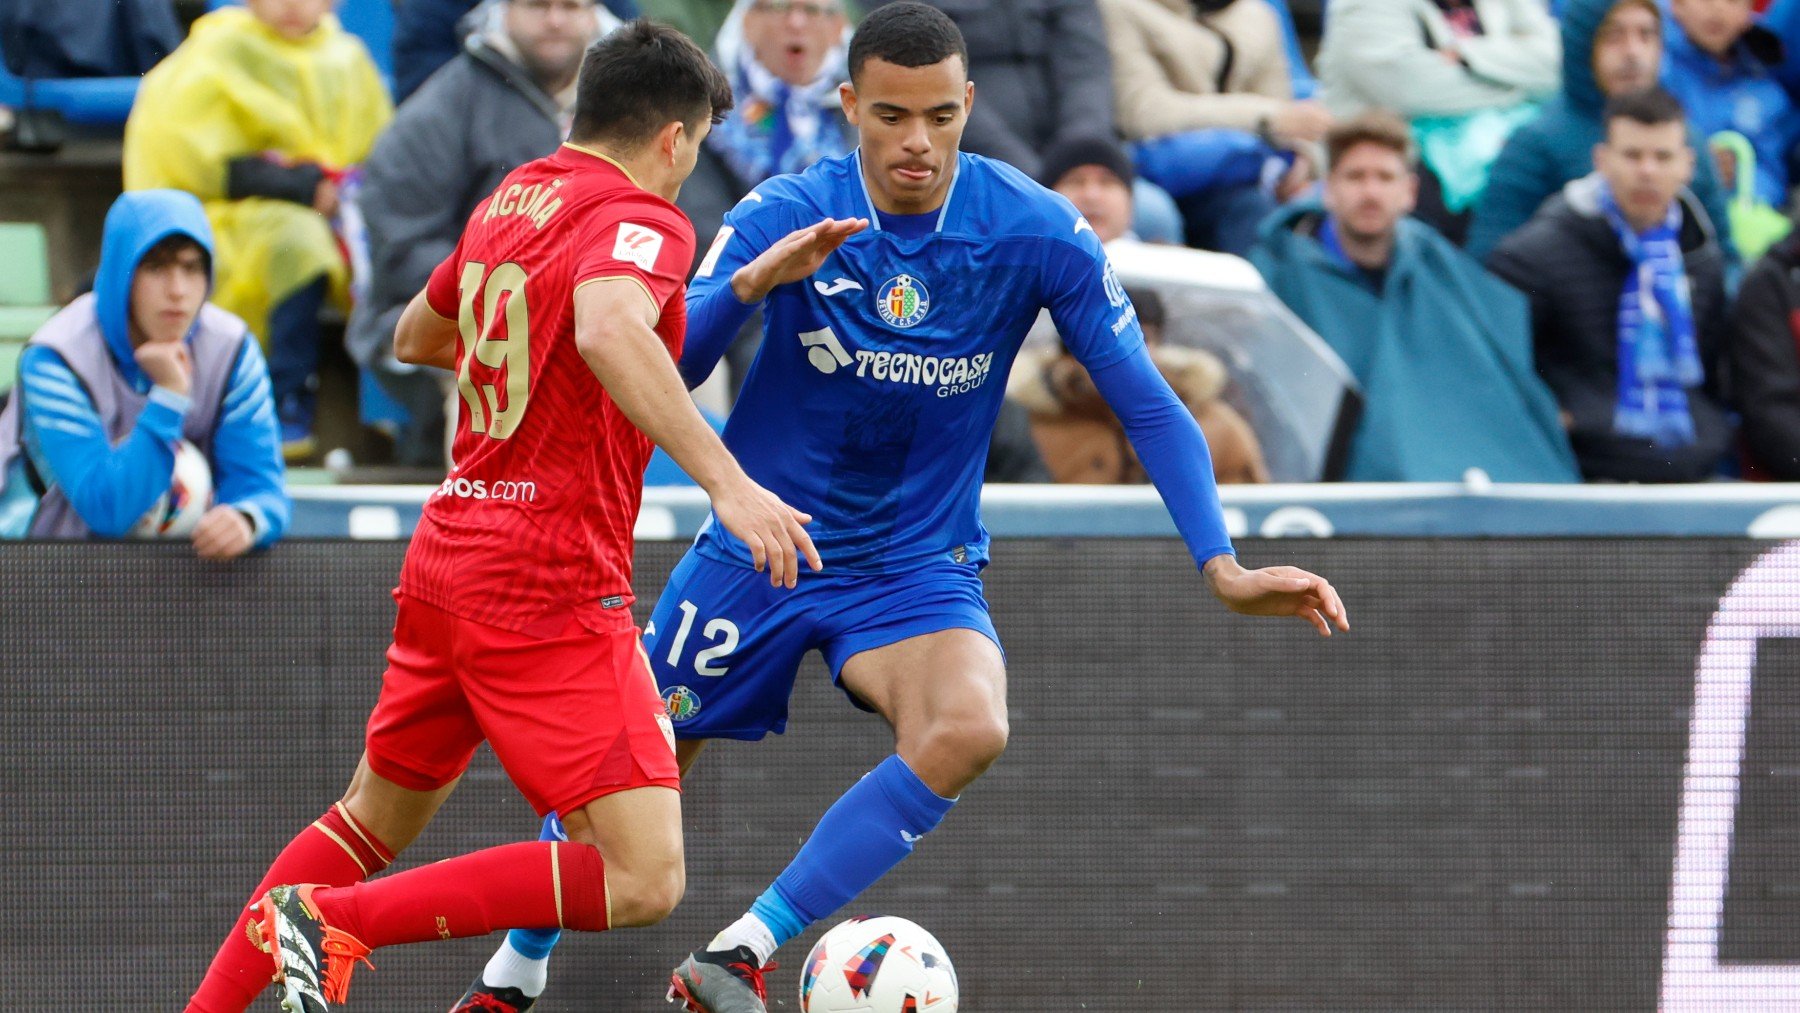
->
[[367, 592, 680, 815]]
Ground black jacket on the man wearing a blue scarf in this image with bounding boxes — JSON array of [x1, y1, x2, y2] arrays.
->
[[1487, 176, 1733, 482]]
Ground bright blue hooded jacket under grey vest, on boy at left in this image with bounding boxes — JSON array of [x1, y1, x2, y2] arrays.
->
[[20, 191, 292, 545]]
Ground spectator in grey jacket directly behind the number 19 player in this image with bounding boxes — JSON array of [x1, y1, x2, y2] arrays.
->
[[346, 0, 617, 466]]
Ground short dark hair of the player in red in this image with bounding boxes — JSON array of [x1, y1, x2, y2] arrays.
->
[[569, 18, 731, 148]]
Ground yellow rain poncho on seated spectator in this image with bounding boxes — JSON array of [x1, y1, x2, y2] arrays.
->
[[124, 7, 394, 349]]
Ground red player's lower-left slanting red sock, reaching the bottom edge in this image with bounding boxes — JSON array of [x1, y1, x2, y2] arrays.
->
[[187, 802, 392, 1013]]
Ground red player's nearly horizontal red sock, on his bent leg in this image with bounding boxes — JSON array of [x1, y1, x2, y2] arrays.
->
[[311, 840, 610, 948]]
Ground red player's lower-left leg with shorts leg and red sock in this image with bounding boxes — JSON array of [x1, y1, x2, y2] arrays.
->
[[187, 599, 481, 1013]]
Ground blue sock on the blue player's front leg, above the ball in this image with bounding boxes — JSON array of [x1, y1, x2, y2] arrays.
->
[[751, 756, 956, 945]]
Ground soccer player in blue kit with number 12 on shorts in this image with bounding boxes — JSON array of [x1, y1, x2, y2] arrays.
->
[[463, 0, 1350, 1013]]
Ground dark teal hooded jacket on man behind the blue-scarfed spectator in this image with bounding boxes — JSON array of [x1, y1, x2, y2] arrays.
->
[[1463, 0, 1737, 263]]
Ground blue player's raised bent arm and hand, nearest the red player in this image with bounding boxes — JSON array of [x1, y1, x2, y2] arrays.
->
[[680, 208, 868, 389]]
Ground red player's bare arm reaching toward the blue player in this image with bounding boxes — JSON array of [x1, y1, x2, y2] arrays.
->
[[574, 277, 824, 587]]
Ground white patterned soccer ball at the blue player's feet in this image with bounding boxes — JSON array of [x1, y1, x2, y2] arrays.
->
[[799, 916, 956, 1013]]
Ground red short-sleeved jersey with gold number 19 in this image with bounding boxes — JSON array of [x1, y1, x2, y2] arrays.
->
[[400, 144, 695, 632]]
